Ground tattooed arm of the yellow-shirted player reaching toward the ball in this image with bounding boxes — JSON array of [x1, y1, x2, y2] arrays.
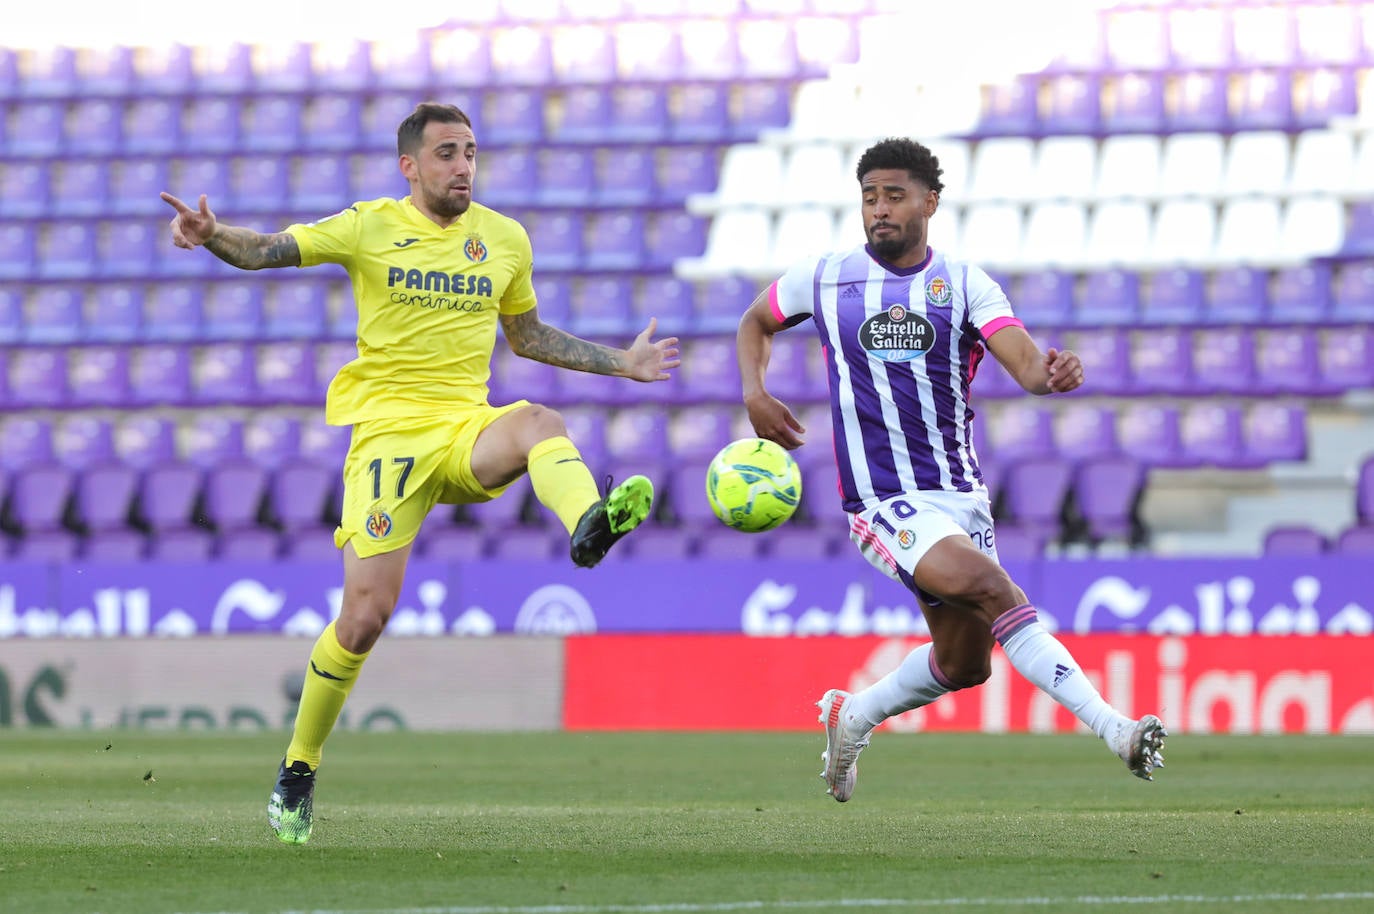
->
[[502, 308, 682, 381]]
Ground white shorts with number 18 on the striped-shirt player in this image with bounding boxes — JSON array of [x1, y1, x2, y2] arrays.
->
[[849, 492, 998, 603]]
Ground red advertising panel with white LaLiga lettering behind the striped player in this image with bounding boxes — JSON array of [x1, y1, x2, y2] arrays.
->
[[563, 635, 1374, 733]]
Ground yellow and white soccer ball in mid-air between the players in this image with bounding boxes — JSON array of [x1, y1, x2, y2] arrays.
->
[[706, 438, 801, 533]]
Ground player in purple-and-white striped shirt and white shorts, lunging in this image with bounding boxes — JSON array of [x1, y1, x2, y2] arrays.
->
[[736, 139, 1168, 803]]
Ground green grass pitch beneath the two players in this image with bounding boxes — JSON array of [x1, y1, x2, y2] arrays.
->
[[0, 727, 1374, 914]]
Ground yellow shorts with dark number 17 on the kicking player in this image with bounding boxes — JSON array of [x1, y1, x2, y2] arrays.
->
[[334, 400, 529, 558]]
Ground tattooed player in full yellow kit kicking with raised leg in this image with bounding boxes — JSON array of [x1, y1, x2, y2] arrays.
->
[[162, 102, 679, 844]]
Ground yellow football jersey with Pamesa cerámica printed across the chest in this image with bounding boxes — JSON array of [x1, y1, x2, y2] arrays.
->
[[286, 197, 534, 425]]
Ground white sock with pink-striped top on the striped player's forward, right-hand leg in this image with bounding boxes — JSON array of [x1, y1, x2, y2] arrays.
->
[[992, 603, 1125, 738]]
